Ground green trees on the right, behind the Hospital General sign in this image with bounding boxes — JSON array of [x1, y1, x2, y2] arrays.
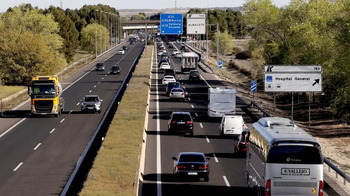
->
[[244, 0, 350, 119]]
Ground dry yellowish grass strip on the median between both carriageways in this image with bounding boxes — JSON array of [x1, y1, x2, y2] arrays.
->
[[79, 46, 153, 196]]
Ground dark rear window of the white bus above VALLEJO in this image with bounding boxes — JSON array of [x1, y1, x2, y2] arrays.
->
[[267, 146, 323, 164]]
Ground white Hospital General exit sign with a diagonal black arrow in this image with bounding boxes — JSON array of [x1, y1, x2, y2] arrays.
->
[[264, 65, 322, 92]]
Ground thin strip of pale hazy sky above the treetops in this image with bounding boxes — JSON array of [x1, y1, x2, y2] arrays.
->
[[0, 0, 290, 12]]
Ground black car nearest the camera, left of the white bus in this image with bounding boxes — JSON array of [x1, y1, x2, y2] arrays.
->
[[173, 152, 209, 182]]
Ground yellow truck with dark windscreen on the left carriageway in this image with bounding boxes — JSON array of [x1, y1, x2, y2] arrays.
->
[[28, 76, 64, 117]]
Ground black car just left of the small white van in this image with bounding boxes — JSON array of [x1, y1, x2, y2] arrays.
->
[[168, 112, 193, 136]]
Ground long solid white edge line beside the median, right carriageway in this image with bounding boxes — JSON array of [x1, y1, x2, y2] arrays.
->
[[156, 46, 162, 196]]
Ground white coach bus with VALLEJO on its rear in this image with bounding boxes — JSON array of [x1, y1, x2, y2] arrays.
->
[[246, 117, 324, 196]]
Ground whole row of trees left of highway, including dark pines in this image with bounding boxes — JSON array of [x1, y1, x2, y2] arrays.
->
[[0, 4, 120, 85]]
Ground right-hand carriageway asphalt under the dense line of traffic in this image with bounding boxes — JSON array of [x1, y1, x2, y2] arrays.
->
[[141, 44, 334, 196]]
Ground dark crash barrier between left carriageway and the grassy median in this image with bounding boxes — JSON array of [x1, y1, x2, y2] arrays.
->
[[60, 43, 145, 196]]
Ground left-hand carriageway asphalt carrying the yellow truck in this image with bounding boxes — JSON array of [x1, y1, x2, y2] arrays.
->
[[0, 43, 143, 195]]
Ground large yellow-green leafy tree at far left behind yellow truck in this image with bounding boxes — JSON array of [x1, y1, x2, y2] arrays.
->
[[0, 7, 66, 84]]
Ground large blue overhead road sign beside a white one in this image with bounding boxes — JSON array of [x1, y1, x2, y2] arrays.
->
[[160, 14, 183, 34]]
